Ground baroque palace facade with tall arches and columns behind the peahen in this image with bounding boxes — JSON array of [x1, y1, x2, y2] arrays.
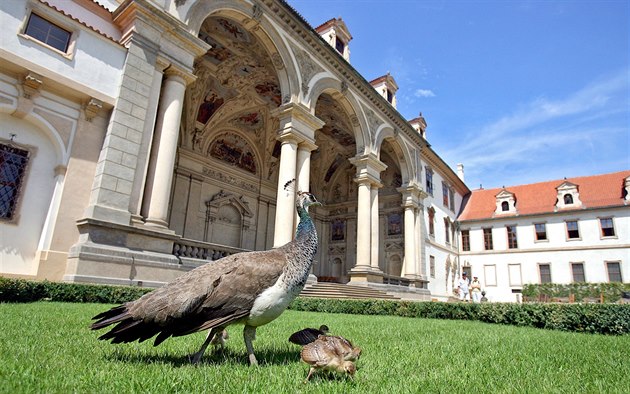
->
[[0, 0, 630, 300]]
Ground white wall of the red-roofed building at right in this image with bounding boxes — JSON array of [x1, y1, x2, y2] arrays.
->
[[460, 207, 630, 302]]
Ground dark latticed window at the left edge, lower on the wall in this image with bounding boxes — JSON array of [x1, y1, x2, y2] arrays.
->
[[0, 144, 29, 220]]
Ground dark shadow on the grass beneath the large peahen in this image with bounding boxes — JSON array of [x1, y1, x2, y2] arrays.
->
[[105, 349, 300, 367]]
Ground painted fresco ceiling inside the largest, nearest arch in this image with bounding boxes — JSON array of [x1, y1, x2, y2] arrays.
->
[[181, 17, 282, 178]]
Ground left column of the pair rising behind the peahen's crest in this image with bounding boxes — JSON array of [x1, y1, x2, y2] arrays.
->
[[273, 135, 298, 248]]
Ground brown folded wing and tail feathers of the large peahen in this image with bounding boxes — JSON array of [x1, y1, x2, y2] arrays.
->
[[92, 249, 286, 345]]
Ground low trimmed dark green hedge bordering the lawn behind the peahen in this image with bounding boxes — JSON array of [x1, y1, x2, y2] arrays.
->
[[0, 277, 630, 335]]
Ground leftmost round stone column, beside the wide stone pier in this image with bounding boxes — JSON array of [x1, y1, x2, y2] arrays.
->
[[146, 66, 194, 228]]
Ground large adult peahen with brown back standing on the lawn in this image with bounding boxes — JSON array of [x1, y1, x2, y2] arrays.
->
[[91, 182, 321, 365]]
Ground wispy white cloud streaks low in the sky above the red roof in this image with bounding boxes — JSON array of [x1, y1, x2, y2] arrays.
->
[[444, 70, 628, 187]]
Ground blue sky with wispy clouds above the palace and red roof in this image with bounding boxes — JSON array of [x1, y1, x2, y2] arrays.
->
[[288, 0, 630, 189]]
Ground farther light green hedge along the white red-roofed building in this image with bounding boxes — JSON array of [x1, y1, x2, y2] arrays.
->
[[523, 282, 630, 302]]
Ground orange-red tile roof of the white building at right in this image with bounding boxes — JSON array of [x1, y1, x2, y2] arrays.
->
[[458, 170, 630, 221]]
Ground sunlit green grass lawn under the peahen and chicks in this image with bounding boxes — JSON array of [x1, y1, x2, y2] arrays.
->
[[0, 302, 630, 394]]
